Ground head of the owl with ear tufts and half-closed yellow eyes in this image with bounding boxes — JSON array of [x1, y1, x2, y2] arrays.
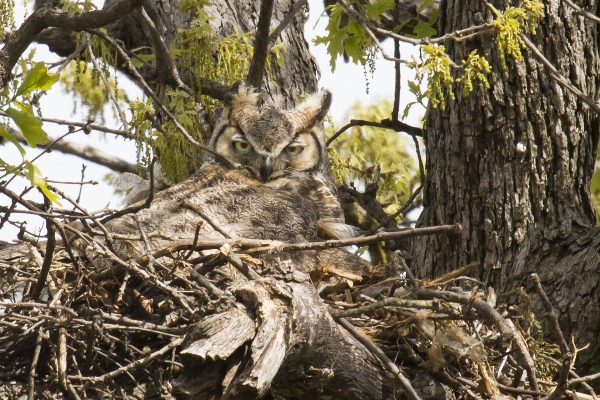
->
[[210, 83, 331, 182]]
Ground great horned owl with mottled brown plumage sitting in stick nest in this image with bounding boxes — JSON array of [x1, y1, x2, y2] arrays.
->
[[111, 83, 355, 245]]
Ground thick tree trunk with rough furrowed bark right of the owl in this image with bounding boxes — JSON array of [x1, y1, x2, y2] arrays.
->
[[412, 0, 600, 370]]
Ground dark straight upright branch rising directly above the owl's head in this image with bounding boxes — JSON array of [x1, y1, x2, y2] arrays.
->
[[246, 0, 275, 90]]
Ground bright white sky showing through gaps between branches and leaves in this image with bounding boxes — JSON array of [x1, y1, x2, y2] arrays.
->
[[0, 0, 423, 241]]
